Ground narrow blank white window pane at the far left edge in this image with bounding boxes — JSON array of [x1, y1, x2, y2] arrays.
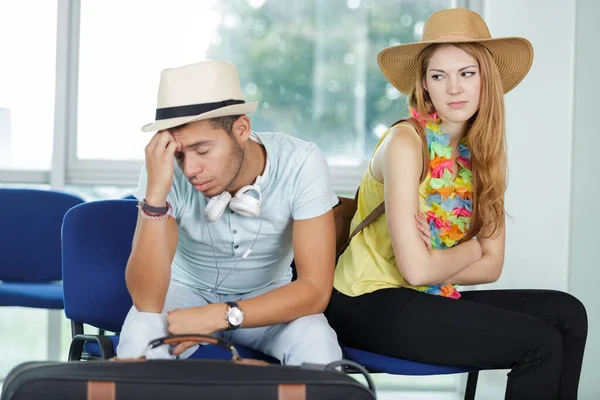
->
[[0, 0, 57, 170]]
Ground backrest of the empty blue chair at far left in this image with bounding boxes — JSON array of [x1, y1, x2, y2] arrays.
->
[[0, 188, 84, 282]]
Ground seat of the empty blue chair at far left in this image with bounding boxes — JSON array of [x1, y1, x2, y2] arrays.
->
[[0, 282, 64, 310]]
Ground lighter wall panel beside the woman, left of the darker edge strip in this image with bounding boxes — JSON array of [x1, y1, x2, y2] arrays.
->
[[484, 0, 575, 290]]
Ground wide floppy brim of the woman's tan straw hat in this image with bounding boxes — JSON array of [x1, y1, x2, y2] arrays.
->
[[377, 37, 533, 95]]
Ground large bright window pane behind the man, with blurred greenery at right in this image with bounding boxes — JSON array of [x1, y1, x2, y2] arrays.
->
[[74, 0, 453, 191]]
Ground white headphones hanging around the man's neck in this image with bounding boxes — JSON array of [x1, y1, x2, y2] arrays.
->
[[204, 158, 269, 222]]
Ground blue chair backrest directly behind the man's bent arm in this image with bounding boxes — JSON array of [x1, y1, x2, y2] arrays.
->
[[62, 199, 138, 332]]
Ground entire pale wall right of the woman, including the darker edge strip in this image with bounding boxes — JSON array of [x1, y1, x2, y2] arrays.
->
[[468, 0, 600, 400]]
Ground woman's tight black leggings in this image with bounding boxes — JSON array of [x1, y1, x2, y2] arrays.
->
[[326, 288, 588, 400]]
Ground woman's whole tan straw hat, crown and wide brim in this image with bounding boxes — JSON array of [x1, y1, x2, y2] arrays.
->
[[377, 8, 533, 94]]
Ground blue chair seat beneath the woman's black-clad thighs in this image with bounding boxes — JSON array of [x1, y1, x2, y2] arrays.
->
[[344, 347, 479, 375]]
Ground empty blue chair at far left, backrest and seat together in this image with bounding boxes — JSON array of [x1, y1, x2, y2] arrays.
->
[[0, 188, 84, 310]]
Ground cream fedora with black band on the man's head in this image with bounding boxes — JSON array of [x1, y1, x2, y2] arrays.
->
[[142, 60, 258, 132]]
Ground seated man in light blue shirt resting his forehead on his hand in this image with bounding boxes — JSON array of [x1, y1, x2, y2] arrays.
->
[[117, 61, 342, 365]]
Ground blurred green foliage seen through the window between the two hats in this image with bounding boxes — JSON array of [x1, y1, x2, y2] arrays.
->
[[208, 0, 451, 165]]
